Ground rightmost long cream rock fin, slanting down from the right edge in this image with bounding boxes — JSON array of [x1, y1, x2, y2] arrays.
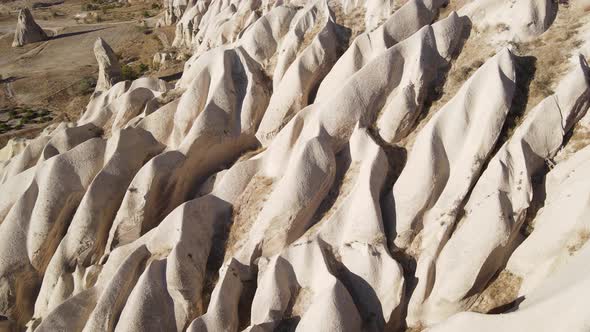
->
[[424, 54, 590, 323]]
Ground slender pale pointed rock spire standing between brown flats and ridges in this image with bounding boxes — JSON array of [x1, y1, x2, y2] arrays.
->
[[94, 37, 121, 91]]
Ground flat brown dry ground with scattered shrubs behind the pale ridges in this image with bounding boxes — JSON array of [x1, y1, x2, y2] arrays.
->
[[0, 1, 182, 146]]
